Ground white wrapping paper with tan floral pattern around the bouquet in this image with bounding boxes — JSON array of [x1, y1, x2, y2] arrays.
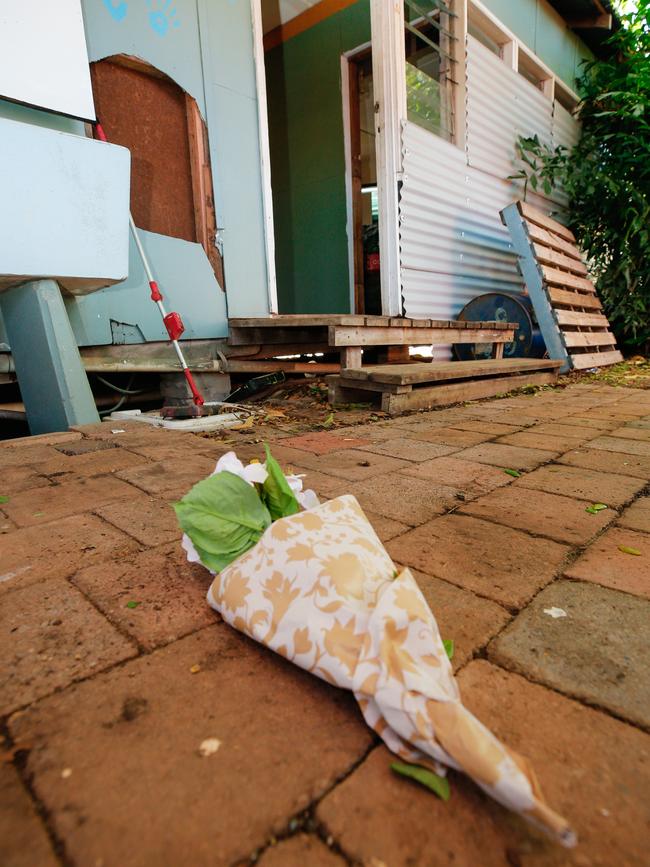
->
[[201, 496, 575, 845]]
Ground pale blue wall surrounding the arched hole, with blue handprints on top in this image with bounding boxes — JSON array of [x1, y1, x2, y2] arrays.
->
[[0, 0, 268, 346]]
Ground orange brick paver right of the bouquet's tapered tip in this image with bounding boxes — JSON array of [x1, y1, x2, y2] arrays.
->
[[459, 661, 650, 867]]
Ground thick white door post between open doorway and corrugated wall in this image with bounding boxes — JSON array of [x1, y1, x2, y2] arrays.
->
[[370, 0, 406, 316]]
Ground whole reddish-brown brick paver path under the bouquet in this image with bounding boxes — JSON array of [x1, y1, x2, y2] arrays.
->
[[0, 384, 650, 867]]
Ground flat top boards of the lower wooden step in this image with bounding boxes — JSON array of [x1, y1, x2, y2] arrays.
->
[[341, 358, 562, 391]]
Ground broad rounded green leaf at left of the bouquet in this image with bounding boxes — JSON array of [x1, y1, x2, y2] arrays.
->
[[173, 472, 271, 572]]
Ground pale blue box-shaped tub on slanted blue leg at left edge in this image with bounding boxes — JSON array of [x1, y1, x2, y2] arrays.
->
[[0, 118, 131, 292]]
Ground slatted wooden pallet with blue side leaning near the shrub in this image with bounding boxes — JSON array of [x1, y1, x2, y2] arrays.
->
[[501, 202, 623, 371]]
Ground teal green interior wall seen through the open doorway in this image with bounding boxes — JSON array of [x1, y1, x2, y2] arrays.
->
[[266, 0, 370, 313]]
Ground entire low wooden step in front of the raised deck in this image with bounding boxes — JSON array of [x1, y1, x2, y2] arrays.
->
[[327, 358, 562, 415]]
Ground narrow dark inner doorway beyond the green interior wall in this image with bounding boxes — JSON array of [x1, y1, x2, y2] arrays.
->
[[347, 49, 382, 315]]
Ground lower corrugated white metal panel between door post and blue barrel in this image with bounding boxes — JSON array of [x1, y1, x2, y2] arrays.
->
[[400, 122, 522, 318]]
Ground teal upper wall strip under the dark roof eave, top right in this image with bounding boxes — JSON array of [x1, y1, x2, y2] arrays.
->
[[483, 0, 593, 90]]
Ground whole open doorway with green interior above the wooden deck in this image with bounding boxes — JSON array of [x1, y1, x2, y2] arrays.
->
[[262, 0, 372, 314]]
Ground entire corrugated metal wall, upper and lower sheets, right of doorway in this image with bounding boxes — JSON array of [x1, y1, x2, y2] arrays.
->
[[400, 36, 578, 319]]
